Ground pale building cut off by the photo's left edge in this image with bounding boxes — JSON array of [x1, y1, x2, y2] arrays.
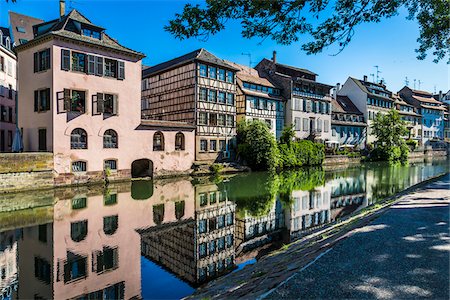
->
[[0, 27, 17, 152]]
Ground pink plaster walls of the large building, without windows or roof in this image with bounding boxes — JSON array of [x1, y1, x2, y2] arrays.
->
[[19, 40, 195, 174]]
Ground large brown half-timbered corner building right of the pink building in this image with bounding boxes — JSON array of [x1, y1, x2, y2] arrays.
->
[[142, 49, 238, 162]]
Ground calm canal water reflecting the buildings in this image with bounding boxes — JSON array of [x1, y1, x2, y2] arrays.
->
[[0, 160, 449, 299]]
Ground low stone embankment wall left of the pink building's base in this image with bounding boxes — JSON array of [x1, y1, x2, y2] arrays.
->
[[0, 153, 54, 193]]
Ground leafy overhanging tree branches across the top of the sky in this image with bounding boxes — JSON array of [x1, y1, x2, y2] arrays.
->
[[165, 0, 450, 63]]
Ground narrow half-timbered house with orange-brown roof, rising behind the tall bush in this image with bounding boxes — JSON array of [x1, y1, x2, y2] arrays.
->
[[228, 62, 285, 139]]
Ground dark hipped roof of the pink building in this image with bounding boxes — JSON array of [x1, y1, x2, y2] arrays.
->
[[14, 9, 145, 58]]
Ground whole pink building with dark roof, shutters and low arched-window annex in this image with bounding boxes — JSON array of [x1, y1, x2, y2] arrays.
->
[[16, 7, 195, 185]]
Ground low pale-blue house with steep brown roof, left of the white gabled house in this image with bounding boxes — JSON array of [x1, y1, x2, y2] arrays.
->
[[331, 96, 367, 149]]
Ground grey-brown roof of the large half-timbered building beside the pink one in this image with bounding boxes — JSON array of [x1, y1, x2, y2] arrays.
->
[[142, 48, 239, 78]]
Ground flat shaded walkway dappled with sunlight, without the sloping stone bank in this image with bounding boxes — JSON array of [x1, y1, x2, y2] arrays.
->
[[265, 175, 450, 299]]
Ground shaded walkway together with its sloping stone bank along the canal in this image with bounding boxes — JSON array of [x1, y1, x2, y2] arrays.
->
[[190, 175, 450, 299]]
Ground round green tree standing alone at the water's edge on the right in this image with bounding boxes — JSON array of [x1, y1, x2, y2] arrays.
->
[[370, 109, 409, 162]]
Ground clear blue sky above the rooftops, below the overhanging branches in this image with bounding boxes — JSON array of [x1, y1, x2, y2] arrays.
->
[[0, 0, 450, 92]]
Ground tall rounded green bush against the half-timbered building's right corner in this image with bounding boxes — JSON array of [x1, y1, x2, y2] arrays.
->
[[237, 120, 279, 170]]
